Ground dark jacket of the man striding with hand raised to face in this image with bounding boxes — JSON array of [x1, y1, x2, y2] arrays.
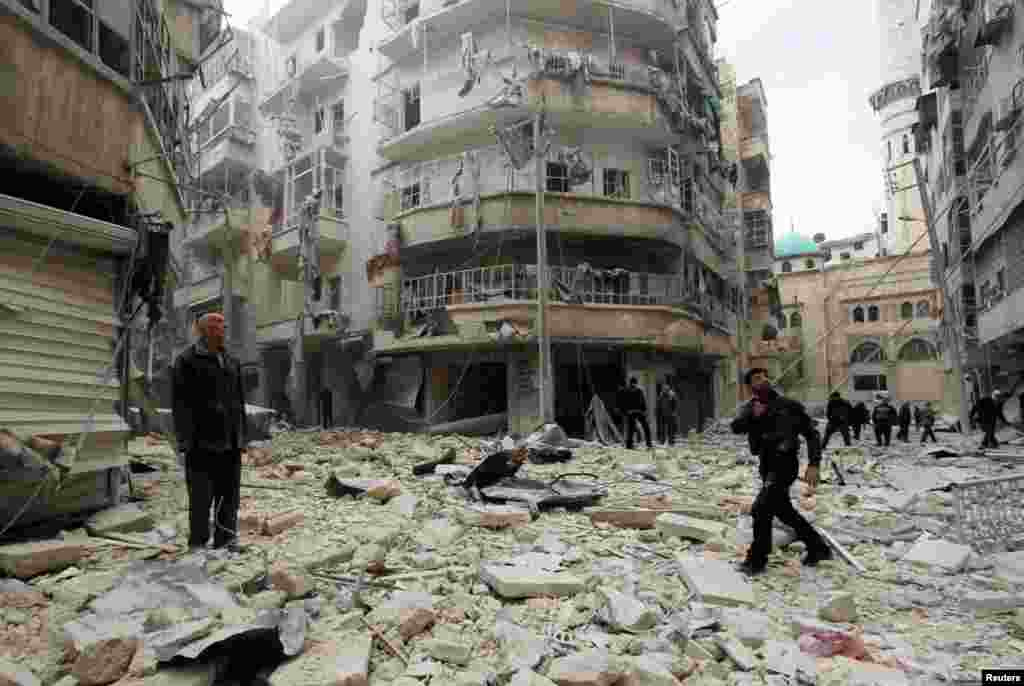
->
[[731, 391, 821, 476]]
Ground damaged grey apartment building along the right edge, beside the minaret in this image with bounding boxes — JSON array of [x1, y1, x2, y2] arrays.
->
[[911, 0, 1024, 411]]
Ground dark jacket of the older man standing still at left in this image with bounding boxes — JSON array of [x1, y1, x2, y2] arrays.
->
[[171, 345, 246, 455]]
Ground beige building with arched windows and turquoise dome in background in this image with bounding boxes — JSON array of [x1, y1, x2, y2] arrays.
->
[[764, 232, 958, 412]]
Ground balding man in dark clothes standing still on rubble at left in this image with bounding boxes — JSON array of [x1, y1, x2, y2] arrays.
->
[[172, 312, 246, 550]]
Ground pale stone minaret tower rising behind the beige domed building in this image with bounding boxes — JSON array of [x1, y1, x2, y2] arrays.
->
[[869, 0, 930, 255]]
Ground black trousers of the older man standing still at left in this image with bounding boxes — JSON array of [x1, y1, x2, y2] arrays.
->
[[185, 451, 242, 547]]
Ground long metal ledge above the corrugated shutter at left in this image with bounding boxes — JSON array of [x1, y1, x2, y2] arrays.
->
[[0, 194, 138, 255]]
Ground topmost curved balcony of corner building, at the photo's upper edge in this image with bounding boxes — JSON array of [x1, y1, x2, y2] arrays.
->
[[377, 0, 685, 61]]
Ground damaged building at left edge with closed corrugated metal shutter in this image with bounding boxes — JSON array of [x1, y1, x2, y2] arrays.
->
[[0, 0, 221, 534]]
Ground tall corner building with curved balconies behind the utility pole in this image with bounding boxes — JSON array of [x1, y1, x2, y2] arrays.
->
[[360, 0, 739, 434]]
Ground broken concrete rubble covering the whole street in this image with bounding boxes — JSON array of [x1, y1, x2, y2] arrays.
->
[[0, 423, 1024, 686]]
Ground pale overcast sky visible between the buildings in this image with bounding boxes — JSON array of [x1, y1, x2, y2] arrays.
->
[[224, 0, 883, 240]]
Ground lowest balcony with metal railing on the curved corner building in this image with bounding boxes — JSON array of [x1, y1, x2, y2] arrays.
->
[[378, 264, 736, 337]]
